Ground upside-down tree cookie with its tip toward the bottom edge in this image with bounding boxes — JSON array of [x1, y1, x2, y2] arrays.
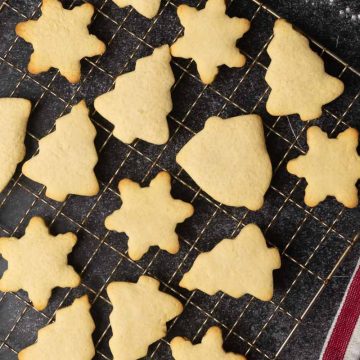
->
[[107, 276, 183, 360]]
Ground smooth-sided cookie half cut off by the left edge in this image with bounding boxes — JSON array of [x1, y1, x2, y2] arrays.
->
[[0, 98, 31, 192]]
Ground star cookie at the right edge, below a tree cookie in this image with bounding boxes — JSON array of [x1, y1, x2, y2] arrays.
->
[[287, 126, 360, 208]]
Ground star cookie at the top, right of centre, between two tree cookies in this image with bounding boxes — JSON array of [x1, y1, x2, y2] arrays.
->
[[171, 0, 250, 84]]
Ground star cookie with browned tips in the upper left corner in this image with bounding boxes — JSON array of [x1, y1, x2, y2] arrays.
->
[[16, 0, 106, 83]]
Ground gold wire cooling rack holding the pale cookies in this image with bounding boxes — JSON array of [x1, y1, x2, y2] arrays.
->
[[0, 0, 360, 359]]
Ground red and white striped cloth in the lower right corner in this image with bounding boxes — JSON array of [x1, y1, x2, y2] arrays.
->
[[320, 263, 360, 360]]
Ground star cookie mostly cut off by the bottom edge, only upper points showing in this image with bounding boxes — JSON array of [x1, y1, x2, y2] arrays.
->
[[170, 326, 246, 360]]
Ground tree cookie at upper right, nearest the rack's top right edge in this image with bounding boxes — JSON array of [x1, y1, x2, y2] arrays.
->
[[265, 19, 344, 121]]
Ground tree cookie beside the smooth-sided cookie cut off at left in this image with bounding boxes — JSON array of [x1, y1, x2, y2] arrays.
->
[[22, 101, 99, 201]]
